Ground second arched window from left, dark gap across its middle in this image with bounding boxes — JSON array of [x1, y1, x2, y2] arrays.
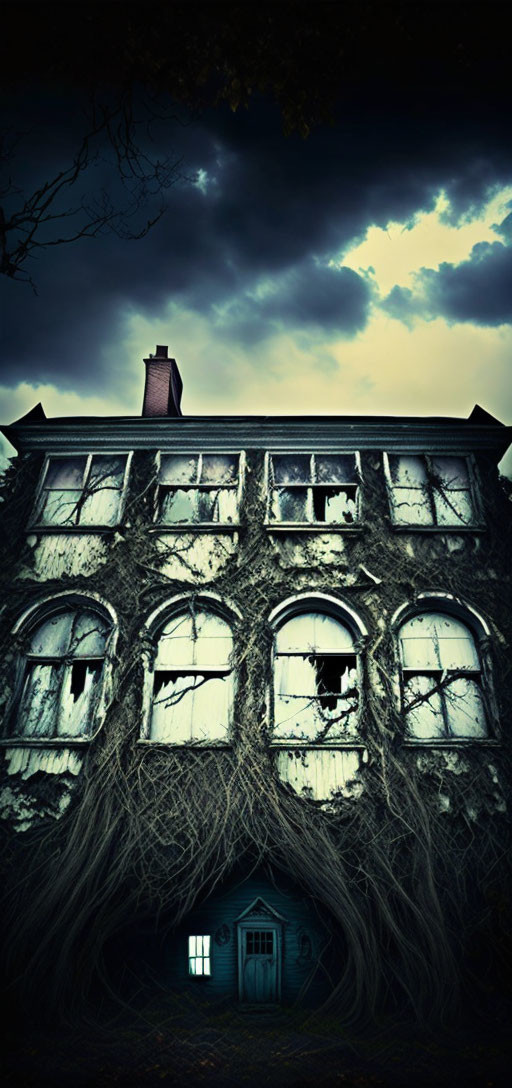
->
[[149, 609, 234, 744]]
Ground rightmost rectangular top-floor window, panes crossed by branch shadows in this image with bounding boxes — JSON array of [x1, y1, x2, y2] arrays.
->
[[384, 454, 477, 529]]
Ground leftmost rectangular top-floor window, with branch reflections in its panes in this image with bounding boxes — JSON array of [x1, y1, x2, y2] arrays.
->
[[33, 454, 127, 529]]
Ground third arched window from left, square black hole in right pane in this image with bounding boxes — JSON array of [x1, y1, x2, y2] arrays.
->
[[272, 611, 359, 744]]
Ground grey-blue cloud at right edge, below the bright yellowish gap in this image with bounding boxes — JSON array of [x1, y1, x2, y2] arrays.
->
[[383, 242, 512, 325]]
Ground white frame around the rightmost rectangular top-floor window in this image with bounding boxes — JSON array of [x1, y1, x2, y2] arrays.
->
[[383, 449, 485, 533]]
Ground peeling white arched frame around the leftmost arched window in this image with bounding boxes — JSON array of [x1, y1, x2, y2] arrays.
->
[[0, 592, 118, 749]]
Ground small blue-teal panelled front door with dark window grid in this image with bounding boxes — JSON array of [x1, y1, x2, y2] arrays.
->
[[238, 920, 280, 1005]]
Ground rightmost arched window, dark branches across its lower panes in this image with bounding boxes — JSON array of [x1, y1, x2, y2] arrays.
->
[[399, 611, 487, 740]]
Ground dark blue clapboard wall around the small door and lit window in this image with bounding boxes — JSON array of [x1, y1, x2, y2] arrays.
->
[[164, 874, 329, 1004]]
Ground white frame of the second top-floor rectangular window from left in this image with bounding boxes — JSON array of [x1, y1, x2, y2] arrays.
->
[[152, 447, 246, 533]]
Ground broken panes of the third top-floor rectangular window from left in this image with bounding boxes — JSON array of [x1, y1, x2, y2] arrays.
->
[[270, 454, 360, 527]]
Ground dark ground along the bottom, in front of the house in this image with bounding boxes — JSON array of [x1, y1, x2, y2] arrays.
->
[[3, 997, 511, 1088]]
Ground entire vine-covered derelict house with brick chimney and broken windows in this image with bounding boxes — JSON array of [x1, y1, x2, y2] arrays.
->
[[1, 347, 511, 1016]]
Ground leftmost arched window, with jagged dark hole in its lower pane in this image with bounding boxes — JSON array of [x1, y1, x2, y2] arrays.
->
[[11, 606, 110, 740]]
